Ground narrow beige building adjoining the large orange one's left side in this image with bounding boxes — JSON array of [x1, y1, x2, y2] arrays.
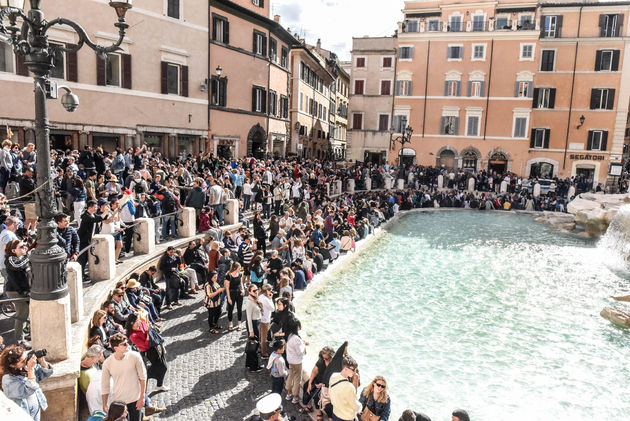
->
[[347, 37, 397, 164]]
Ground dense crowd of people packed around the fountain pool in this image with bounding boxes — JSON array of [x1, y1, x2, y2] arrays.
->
[[0, 141, 628, 421]]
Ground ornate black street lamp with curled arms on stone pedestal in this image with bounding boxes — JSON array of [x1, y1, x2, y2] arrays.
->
[[0, 0, 132, 300]]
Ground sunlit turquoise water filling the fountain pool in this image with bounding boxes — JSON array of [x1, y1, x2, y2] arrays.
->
[[300, 211, 630, 421]]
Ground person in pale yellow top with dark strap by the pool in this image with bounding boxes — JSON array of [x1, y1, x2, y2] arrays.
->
[[328, 355, 361, 421]]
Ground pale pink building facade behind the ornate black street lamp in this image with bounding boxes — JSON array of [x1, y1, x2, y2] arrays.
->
[[0, 0, 208, 157]]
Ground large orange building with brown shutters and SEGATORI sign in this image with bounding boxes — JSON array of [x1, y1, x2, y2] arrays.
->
[[398, 0, 630, 184]]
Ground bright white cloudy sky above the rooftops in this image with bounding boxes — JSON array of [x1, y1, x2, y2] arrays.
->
[[271, 0, 404, 60]]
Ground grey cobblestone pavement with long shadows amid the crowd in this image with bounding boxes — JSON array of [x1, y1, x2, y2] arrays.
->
[[147, 293, 309, 421]]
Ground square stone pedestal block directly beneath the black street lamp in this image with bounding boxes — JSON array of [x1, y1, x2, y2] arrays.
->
[[30, 294, 71, 361]]
